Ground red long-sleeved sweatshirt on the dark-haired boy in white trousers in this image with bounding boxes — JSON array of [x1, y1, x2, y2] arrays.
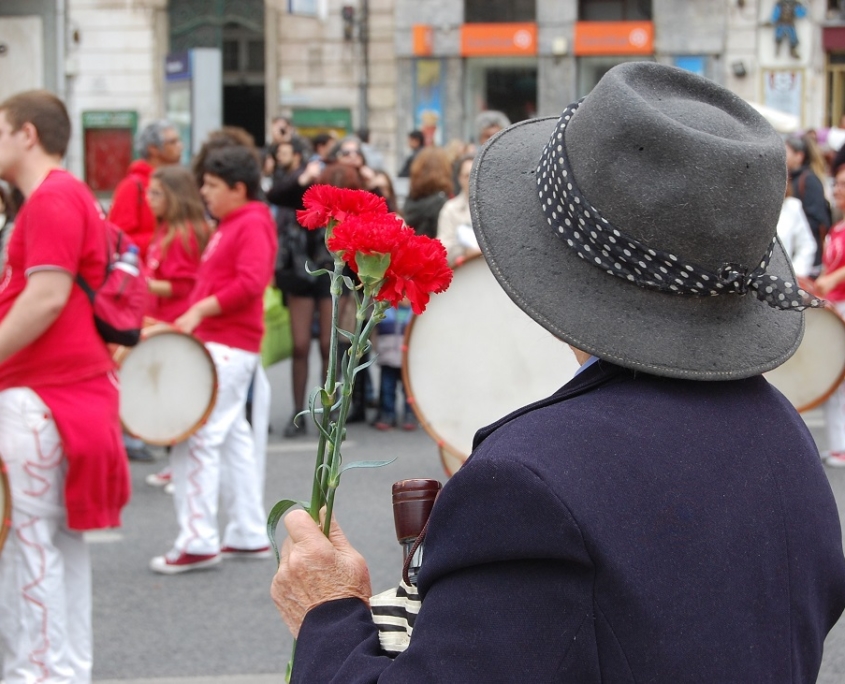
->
[[191, 202, 277, 353]]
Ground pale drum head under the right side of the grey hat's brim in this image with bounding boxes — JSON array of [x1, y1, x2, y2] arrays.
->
[[765, 308, 845, 411]]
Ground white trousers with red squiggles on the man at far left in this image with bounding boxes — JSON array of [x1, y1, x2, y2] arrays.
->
[[0, 388, 92, 684]]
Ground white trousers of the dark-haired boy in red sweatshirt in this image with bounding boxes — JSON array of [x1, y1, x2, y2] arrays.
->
[[171, 342, 269, 555]]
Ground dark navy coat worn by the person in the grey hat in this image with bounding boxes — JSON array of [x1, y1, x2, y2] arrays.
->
[[294, 361, 845, 684]]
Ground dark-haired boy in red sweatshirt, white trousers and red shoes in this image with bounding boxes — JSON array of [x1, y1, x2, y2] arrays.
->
[[150, 145, 277, 574]]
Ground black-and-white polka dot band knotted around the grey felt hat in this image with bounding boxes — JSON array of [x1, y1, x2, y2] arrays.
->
[[537, 102, 824, 311]]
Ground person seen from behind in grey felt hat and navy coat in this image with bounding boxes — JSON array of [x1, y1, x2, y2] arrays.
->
[[272, 62, 845, 684]]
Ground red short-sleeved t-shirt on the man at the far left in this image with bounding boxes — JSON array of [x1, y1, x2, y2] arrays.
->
[[0, 170, 114, 390]]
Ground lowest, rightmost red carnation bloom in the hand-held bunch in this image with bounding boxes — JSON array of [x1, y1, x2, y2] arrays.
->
[[376, 235, 452, 315]]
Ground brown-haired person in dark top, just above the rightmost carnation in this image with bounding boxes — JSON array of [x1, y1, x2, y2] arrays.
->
[[402, 147, 455, 237]]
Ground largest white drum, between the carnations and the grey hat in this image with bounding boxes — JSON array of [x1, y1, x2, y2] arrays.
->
[[403, 256, 578, 475]]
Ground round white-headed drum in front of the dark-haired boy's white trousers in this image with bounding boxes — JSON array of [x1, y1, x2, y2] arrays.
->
[[114, 324, 217, 446]]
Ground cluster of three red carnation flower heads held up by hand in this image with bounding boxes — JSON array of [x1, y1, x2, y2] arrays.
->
[[297, 185, 452, 314]]
